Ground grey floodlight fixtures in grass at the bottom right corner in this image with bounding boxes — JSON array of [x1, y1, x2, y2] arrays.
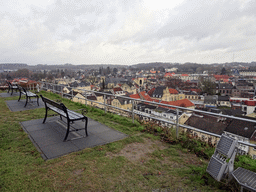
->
[[206, 134, 256, 191]]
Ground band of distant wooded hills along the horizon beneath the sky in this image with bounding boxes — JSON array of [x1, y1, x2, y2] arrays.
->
[[0, 61, 256, 74]]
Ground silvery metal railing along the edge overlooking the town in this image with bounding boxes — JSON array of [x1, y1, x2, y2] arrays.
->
[[40, 82, 256, 148]]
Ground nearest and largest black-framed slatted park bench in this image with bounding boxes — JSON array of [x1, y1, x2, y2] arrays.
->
[[40, 95, 88, 141]]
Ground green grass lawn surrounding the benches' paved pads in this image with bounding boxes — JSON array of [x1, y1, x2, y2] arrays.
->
[[0, 92, 230, 191]]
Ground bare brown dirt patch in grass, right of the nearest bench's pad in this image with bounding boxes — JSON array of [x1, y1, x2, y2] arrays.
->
[[106, 138, 167, 161]]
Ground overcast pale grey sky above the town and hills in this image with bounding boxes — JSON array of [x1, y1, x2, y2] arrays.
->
[[0, 0, 256, 65]]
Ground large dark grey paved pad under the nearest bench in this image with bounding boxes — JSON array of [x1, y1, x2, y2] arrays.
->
[[21, 116, 127, 160]]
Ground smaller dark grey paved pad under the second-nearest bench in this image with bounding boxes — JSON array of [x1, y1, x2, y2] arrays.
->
[[5, 98, 45, 112]]
